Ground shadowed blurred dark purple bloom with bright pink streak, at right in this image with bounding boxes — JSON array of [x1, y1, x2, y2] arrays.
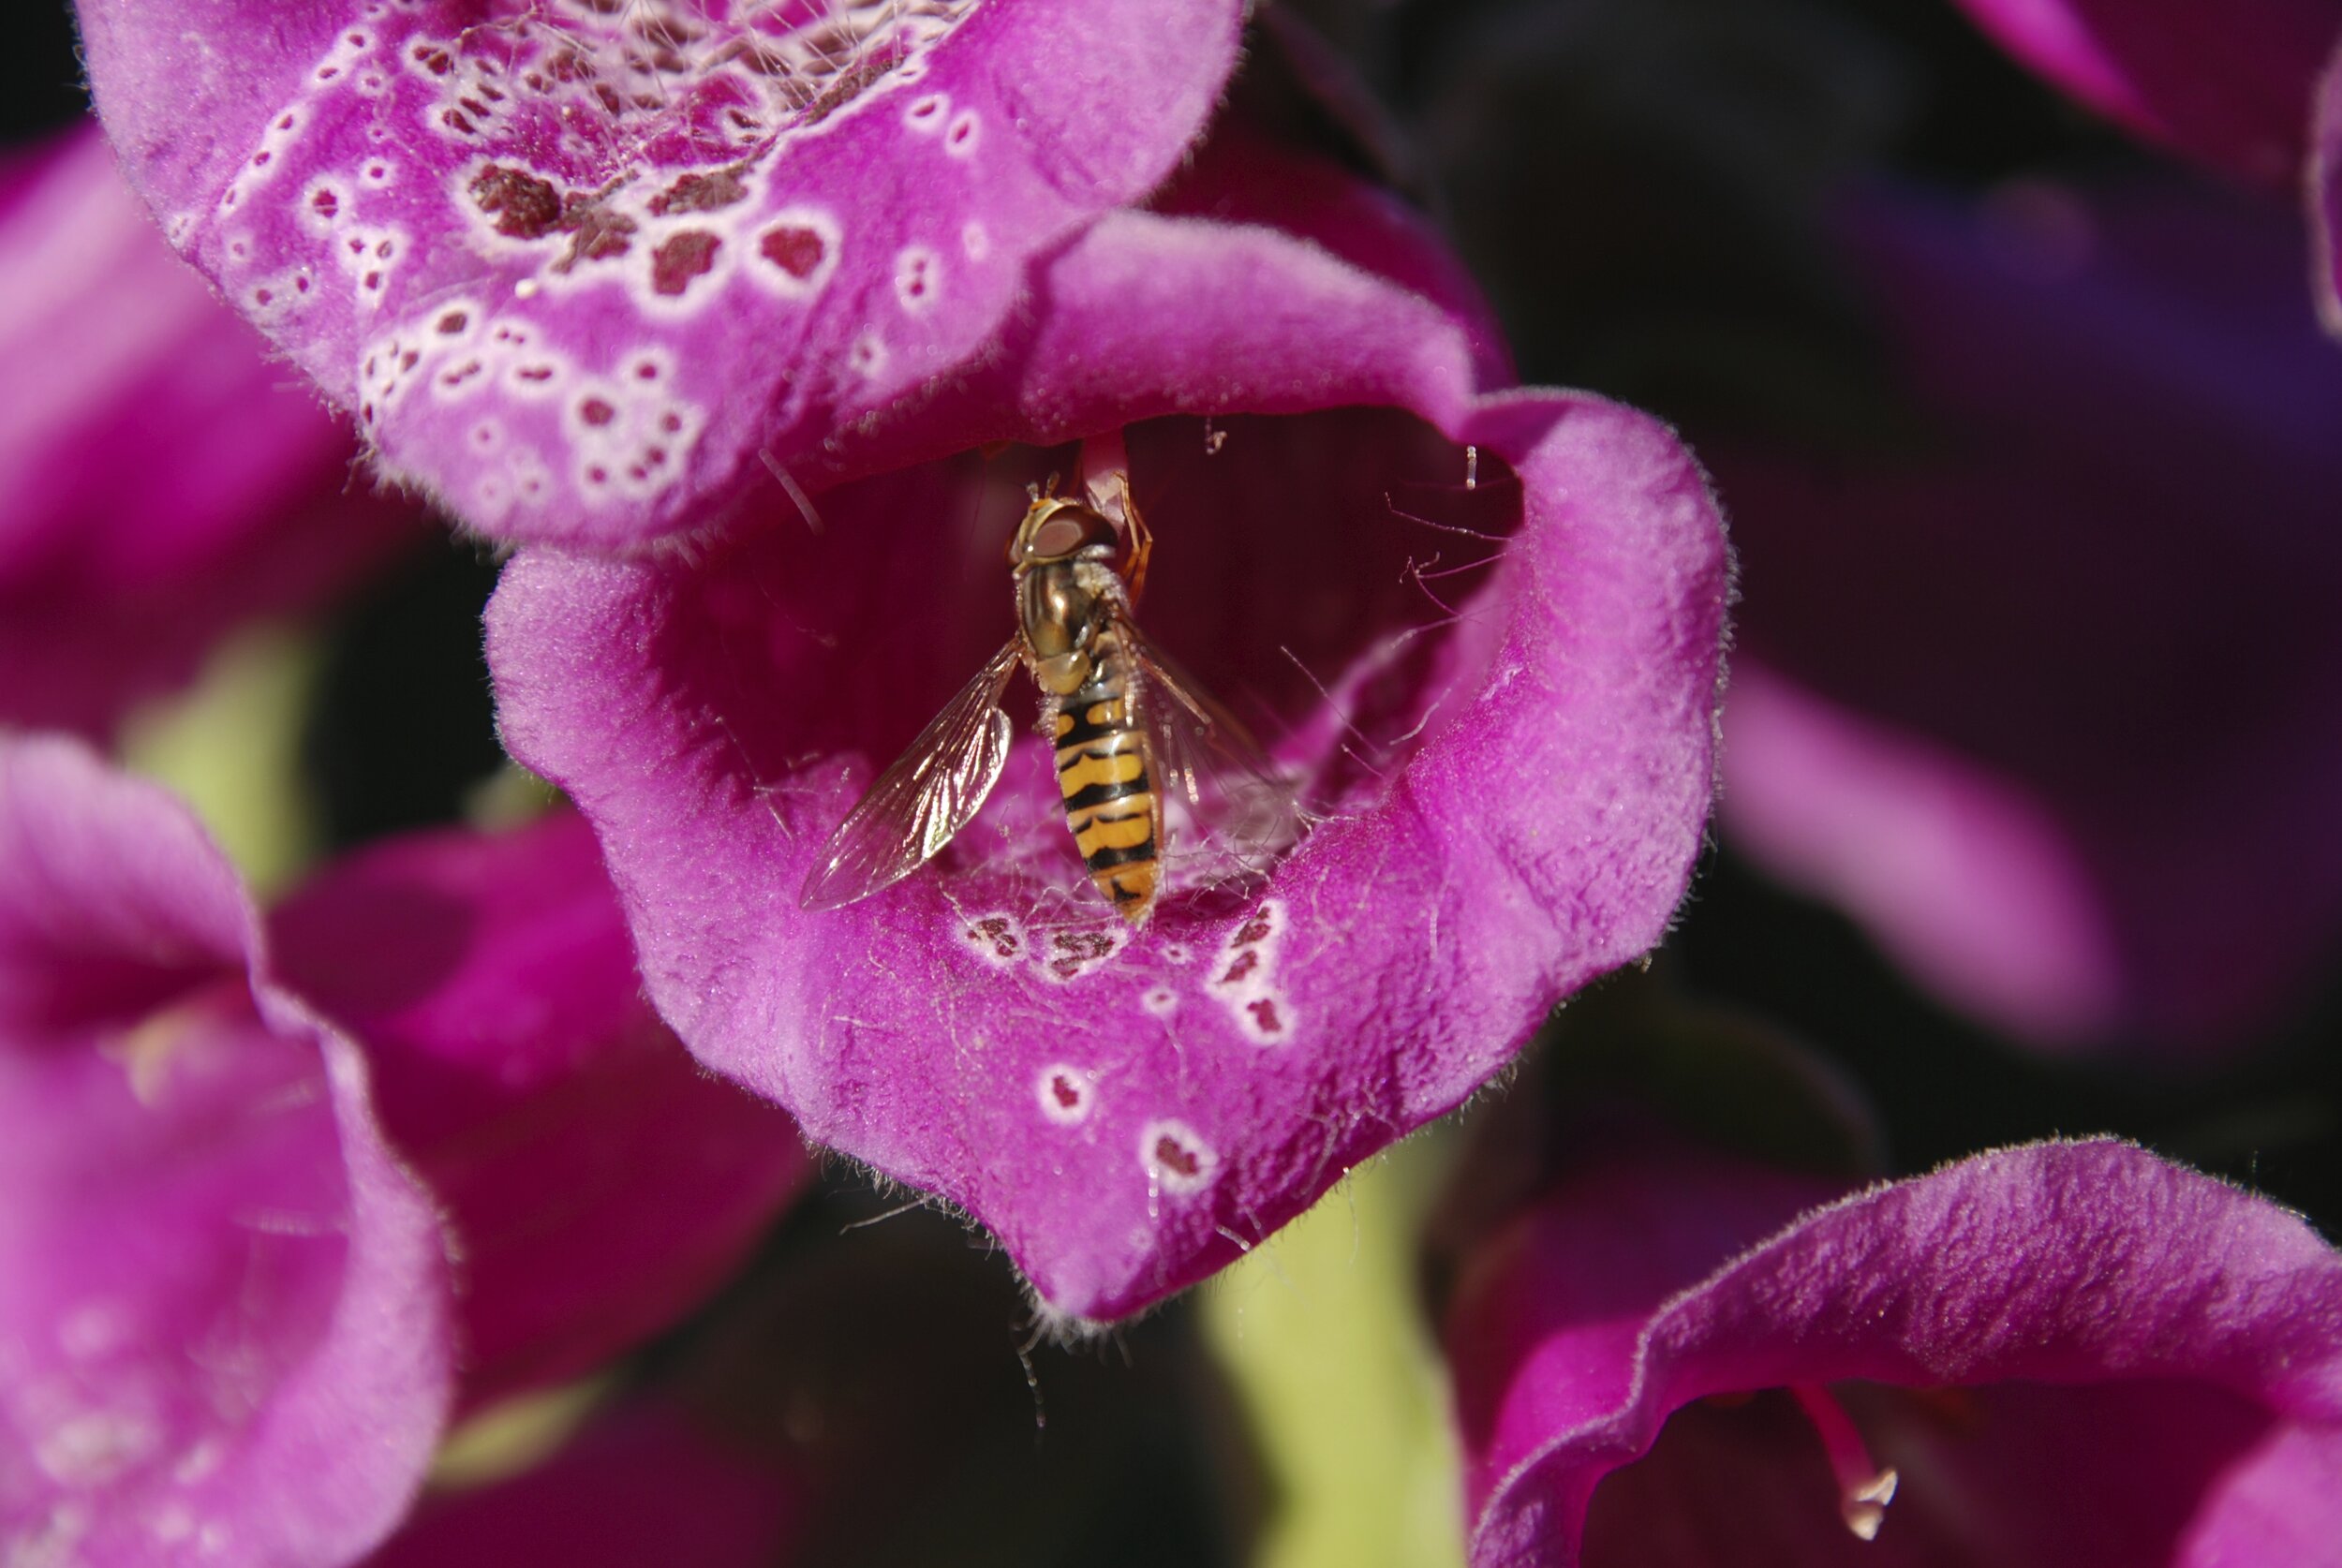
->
[[1700, 175, 2342, 1048]]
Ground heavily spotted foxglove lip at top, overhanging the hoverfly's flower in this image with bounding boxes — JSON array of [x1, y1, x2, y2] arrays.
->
[[80, 0, 1239, 545]]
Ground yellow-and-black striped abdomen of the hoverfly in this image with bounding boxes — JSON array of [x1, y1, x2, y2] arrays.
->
[[1057, 629, 1157, 925]]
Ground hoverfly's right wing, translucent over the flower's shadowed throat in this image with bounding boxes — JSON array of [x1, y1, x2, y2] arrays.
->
[[1115, 615, 1307, 868]]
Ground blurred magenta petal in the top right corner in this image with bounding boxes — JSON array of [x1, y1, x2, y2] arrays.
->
[[1961, 0, 2342, 187]]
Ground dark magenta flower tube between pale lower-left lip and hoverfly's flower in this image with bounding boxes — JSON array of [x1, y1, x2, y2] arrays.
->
[[270, 812, 810, 1404]]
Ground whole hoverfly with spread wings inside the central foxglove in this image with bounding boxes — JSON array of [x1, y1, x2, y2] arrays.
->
[[799, 473, 1300, 925]]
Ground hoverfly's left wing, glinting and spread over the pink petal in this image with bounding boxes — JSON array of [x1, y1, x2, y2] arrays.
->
[[796, 642, 1016, 910]]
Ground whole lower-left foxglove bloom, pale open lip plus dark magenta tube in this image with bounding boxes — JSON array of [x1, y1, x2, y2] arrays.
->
[[0, 740, 808, 1563]]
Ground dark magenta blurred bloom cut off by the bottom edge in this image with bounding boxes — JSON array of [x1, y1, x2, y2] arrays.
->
[[365, 1402, 801, 1568]]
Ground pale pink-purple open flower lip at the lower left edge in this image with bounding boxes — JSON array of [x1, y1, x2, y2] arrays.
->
[[0, 740, 450, 1563]]
